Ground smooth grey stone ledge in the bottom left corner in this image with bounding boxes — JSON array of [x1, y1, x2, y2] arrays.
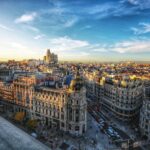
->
[[0, 117, 50, 150]]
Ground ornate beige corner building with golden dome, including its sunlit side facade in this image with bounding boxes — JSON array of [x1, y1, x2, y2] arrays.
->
[[31, 73, 87, 135]]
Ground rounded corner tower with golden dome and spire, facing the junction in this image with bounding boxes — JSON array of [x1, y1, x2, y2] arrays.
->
[[67, 70, 87, 135]]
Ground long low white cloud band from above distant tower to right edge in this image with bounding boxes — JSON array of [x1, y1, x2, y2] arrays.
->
[[50, 36, 150, 56]]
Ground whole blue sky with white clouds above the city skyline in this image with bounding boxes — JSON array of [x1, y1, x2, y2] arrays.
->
[[0, 0, 150, 61]]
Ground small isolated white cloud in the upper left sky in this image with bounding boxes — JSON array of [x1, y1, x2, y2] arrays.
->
[[15, 12, 37, 23]]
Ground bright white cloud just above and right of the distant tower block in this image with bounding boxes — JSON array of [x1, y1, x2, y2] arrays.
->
[[49, 36, 89, 51]]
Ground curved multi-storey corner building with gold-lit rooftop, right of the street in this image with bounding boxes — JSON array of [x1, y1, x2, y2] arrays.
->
[[102, 76, 142, 121]]
